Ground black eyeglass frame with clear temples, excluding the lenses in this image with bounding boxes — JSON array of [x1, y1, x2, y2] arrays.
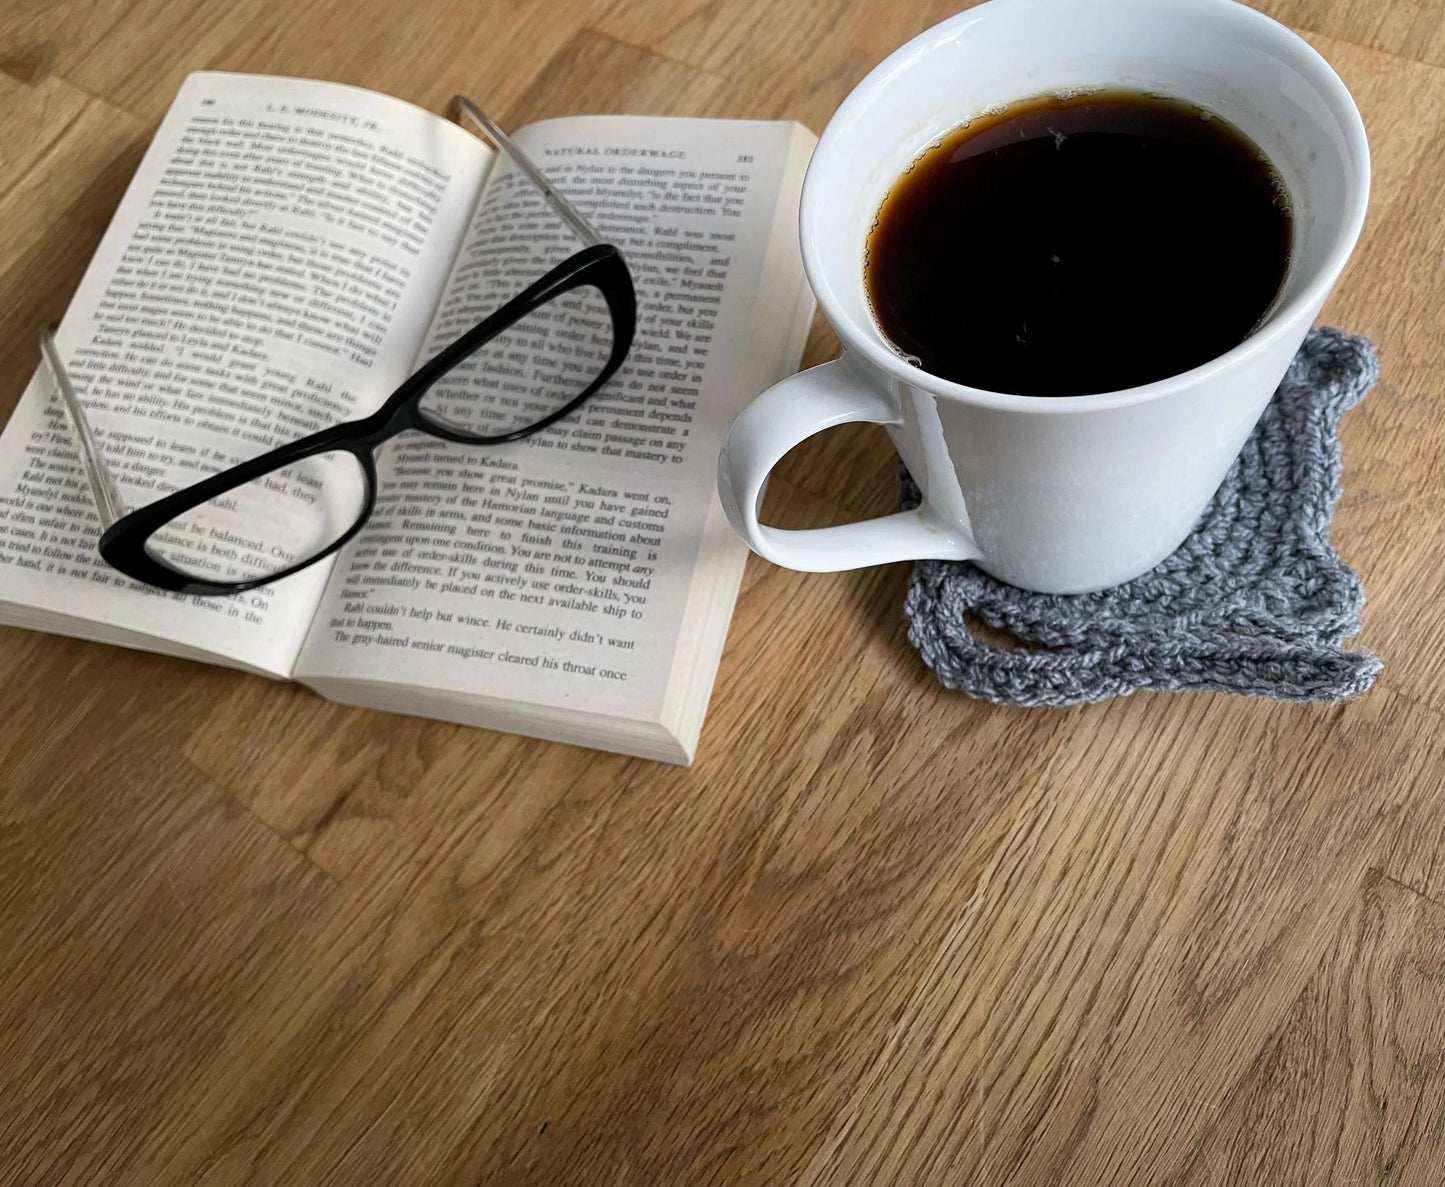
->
[[40, 95, 637, 596]]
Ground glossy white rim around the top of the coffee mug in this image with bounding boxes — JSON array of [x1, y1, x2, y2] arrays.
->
[[799, 0, 1371, 413]]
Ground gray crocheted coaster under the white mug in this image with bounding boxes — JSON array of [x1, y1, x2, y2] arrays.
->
[[903, 330, 1383, 706]]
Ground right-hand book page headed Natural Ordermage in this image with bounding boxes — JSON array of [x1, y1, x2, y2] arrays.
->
[[298, 117, 811, 720]]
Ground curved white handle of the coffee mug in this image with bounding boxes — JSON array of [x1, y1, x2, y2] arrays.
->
[[718, 356, 981, 573]]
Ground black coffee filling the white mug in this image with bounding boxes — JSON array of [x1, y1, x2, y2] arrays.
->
[[866, 91, 1293, 396]]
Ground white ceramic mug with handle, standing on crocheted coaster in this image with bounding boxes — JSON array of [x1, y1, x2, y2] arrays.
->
[[718, 0, 1370, 593]]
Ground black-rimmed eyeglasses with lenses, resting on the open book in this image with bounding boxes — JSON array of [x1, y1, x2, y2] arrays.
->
[[40, 95, 637, 594]]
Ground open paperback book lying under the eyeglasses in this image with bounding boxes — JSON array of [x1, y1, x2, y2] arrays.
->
[[0, 74, 814, 762]]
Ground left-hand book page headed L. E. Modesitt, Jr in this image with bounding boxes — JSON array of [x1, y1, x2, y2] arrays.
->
[[0, 74, 493, 674]]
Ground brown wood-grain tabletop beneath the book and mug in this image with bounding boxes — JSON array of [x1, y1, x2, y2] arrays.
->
[[0, 0, 1445, 1187]]
